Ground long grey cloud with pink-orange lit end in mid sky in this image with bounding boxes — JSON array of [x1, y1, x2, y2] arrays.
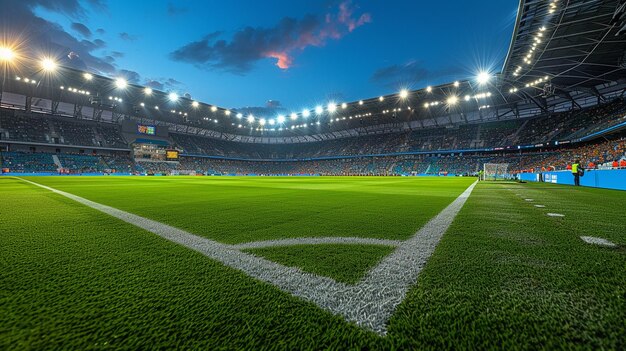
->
[[170, 1, 372, 74]]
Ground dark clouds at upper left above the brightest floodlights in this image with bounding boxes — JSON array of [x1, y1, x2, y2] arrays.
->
[[0, 0, 116, 73]]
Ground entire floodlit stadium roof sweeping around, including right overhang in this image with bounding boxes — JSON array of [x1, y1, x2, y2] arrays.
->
[[0, 0, 626, 142]]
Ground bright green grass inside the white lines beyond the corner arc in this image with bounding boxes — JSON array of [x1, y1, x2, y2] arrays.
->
[[27, 177, 473, 244]]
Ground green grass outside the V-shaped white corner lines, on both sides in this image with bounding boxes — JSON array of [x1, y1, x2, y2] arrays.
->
[[0, 177, 626, 350]]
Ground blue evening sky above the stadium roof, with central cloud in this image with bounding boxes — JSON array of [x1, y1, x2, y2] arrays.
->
[[29, 0, 519, 110]]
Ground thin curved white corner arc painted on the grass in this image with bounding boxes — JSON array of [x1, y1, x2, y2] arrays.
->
[[231, 237, 402, 250]]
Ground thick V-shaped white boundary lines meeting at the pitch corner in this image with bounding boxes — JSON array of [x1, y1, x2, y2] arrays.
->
[[16, 177, 478, 335]]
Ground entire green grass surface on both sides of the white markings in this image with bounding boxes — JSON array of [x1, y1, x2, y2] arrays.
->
[[0, 177, 626, 350]]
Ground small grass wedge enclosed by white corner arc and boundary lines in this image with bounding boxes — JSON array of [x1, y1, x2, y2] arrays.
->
[[244, 244, 394, 284]]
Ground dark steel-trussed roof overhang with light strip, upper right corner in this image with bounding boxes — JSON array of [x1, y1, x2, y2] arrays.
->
[[502, 0, 626, 100]]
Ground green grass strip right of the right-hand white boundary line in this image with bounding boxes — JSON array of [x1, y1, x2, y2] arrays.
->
[[389, 183, 626, 349]]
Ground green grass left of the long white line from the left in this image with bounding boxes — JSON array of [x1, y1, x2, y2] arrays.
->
[[0, 178, 387, 350]]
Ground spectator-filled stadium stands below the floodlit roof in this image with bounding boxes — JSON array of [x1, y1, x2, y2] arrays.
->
[[0, 98, 626, 175]]
